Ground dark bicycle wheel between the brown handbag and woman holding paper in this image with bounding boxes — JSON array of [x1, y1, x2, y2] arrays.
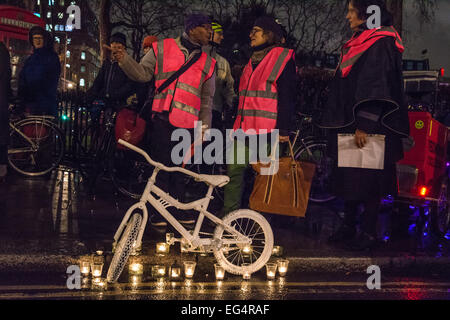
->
[[295, 140, 336, 203]]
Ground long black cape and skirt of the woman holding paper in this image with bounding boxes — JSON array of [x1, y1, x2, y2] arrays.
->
[[318, 37, 409, 200]]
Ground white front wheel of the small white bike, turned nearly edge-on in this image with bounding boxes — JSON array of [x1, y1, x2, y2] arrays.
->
[[106, 213, 142, 283]]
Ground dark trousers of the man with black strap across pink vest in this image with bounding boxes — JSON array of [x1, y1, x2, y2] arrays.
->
[[149, 115, 193, 202]]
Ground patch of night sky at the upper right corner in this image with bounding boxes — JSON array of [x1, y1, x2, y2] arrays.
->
[[403, 0, 450, 73]]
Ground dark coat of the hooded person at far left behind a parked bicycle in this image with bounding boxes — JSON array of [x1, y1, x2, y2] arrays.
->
[[18, 45, 61, 116]]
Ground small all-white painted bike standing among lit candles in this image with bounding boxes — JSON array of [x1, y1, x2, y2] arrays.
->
[[107, 140, 273, 283]]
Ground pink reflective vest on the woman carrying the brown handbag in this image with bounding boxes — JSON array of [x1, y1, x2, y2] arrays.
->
[[234, 48, 294, 133]]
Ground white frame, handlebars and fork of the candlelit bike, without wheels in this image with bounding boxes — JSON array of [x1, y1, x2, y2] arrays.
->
[[114, 140, 251, 250]]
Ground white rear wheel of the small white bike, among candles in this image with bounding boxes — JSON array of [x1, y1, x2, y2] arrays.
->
[[213, 210, 273, 275]]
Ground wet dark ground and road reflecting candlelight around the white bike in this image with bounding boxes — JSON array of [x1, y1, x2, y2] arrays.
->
[[0, 168, 450, 300]]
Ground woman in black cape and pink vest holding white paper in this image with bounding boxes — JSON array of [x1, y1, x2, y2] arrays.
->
[[319, 0, 409, 250]]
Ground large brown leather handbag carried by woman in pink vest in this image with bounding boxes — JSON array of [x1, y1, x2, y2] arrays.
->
[[250, 142, 316, 218]]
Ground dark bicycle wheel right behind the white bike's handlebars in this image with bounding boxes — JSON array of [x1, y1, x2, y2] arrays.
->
[[109, 149, 154, 199]]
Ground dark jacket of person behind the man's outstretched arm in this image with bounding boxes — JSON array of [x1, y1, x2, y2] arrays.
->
[[88, 60, 137, 105]]
